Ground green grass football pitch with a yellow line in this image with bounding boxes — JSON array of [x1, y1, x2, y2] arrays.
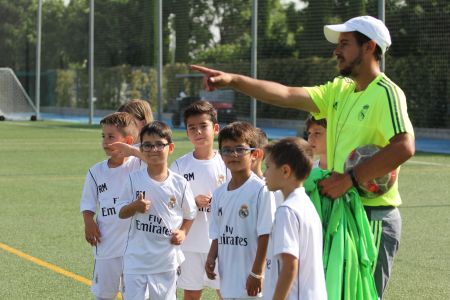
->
[[0, 121, 450, 299]]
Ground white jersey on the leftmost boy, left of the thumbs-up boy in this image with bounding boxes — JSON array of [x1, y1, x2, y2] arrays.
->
[[80, 157, 147, 259]]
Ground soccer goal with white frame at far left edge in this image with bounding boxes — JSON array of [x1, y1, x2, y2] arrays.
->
[[0, 68, 37, 120]]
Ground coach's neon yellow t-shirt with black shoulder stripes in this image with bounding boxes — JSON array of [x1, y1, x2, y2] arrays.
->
[[306, 73, 414, 206]]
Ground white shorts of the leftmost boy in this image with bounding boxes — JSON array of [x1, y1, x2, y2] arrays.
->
[[91, 257, 123, 298]]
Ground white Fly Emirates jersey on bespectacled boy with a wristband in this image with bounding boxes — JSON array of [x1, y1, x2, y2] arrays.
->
[[210, 173, 275, 298]]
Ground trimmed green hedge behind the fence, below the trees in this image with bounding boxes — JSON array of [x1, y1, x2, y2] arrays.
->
[[50, 56, 450, 128]]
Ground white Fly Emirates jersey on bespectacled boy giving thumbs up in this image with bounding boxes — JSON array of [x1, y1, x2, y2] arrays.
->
[[117, 169, 197, 274]]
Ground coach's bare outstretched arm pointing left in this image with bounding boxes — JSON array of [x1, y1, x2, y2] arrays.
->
[[191, 65, 319, 112]]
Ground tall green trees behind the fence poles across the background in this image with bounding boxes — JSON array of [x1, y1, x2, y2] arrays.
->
[[0, 0, 450, 127]]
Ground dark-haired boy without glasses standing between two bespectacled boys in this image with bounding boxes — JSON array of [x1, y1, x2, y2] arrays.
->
[[170, 100, 230, 300]]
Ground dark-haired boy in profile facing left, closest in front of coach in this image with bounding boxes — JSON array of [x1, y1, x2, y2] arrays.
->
[[264, 138, 327, 300]]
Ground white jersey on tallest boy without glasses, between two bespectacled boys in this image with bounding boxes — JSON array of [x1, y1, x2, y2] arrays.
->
[[170, 152, 230, 253]]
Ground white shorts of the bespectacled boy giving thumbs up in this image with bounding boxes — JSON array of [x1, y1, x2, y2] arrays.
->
[[123, 270, 177, 300]]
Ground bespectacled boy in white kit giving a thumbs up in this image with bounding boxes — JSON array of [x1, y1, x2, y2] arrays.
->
[[117, 121, 197, 300]]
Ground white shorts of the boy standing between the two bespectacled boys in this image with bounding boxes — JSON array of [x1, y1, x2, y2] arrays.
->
[[177, 252, 220, 291]]
